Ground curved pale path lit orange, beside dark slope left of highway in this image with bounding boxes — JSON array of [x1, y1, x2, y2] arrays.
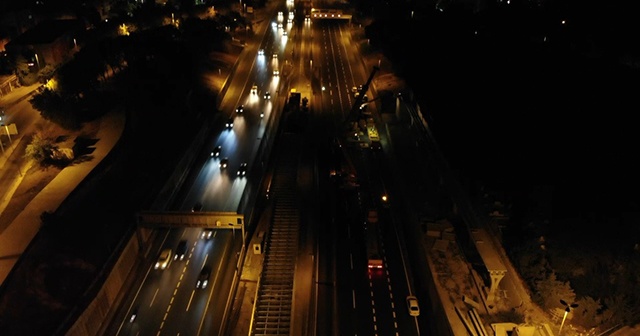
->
[[0, 102, 125, 283]]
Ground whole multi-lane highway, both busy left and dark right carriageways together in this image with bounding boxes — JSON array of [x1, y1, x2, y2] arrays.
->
[[105, 3, 423, 335]]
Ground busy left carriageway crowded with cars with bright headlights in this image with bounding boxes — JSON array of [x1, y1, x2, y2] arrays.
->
[[106, 1, 290, 335]]
